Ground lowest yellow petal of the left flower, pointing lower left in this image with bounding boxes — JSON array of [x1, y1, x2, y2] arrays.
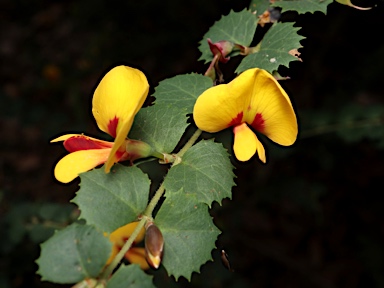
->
[[54, 149, 111, 183]]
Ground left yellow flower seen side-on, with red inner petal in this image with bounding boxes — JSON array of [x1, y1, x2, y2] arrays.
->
[[51, 66, 149, 183]]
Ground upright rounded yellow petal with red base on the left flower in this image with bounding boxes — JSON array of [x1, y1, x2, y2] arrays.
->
[[92, 66, 149, 137]]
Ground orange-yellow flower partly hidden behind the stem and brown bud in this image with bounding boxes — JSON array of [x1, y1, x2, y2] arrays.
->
[[107, 222, 149, 270]]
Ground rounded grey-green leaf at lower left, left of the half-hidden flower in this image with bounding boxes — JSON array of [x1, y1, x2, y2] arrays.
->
[[36, 223, 112, 284]]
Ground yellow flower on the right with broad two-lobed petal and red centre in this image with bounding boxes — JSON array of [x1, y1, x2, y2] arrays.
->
[[193, 68, 298, 163]]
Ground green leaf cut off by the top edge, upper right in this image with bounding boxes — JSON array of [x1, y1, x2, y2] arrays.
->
[[272, 0, 333, 14]]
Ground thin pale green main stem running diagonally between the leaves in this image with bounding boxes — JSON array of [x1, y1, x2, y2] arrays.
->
[[100, 129, 203, 279]]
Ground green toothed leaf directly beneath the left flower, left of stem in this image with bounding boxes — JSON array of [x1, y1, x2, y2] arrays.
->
[[72, 164, 150, 232]]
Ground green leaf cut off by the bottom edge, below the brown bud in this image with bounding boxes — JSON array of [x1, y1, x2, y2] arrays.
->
[[107, 264, 155, 288]]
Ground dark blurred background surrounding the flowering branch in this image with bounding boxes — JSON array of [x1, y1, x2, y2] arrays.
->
[[0, 0, 384, 288]]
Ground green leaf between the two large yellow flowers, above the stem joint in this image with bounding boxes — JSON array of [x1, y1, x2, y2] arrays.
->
[[129, 74, 212, 153]]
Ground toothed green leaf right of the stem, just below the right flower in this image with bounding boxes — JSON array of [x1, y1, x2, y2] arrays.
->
[[164, 140, 235, 206]]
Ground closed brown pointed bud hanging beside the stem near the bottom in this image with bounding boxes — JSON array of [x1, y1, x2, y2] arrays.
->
[[145, 222, 164, 269]]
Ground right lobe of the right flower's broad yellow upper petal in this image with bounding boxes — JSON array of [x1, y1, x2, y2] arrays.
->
[[243, 68, 298, 146]]
